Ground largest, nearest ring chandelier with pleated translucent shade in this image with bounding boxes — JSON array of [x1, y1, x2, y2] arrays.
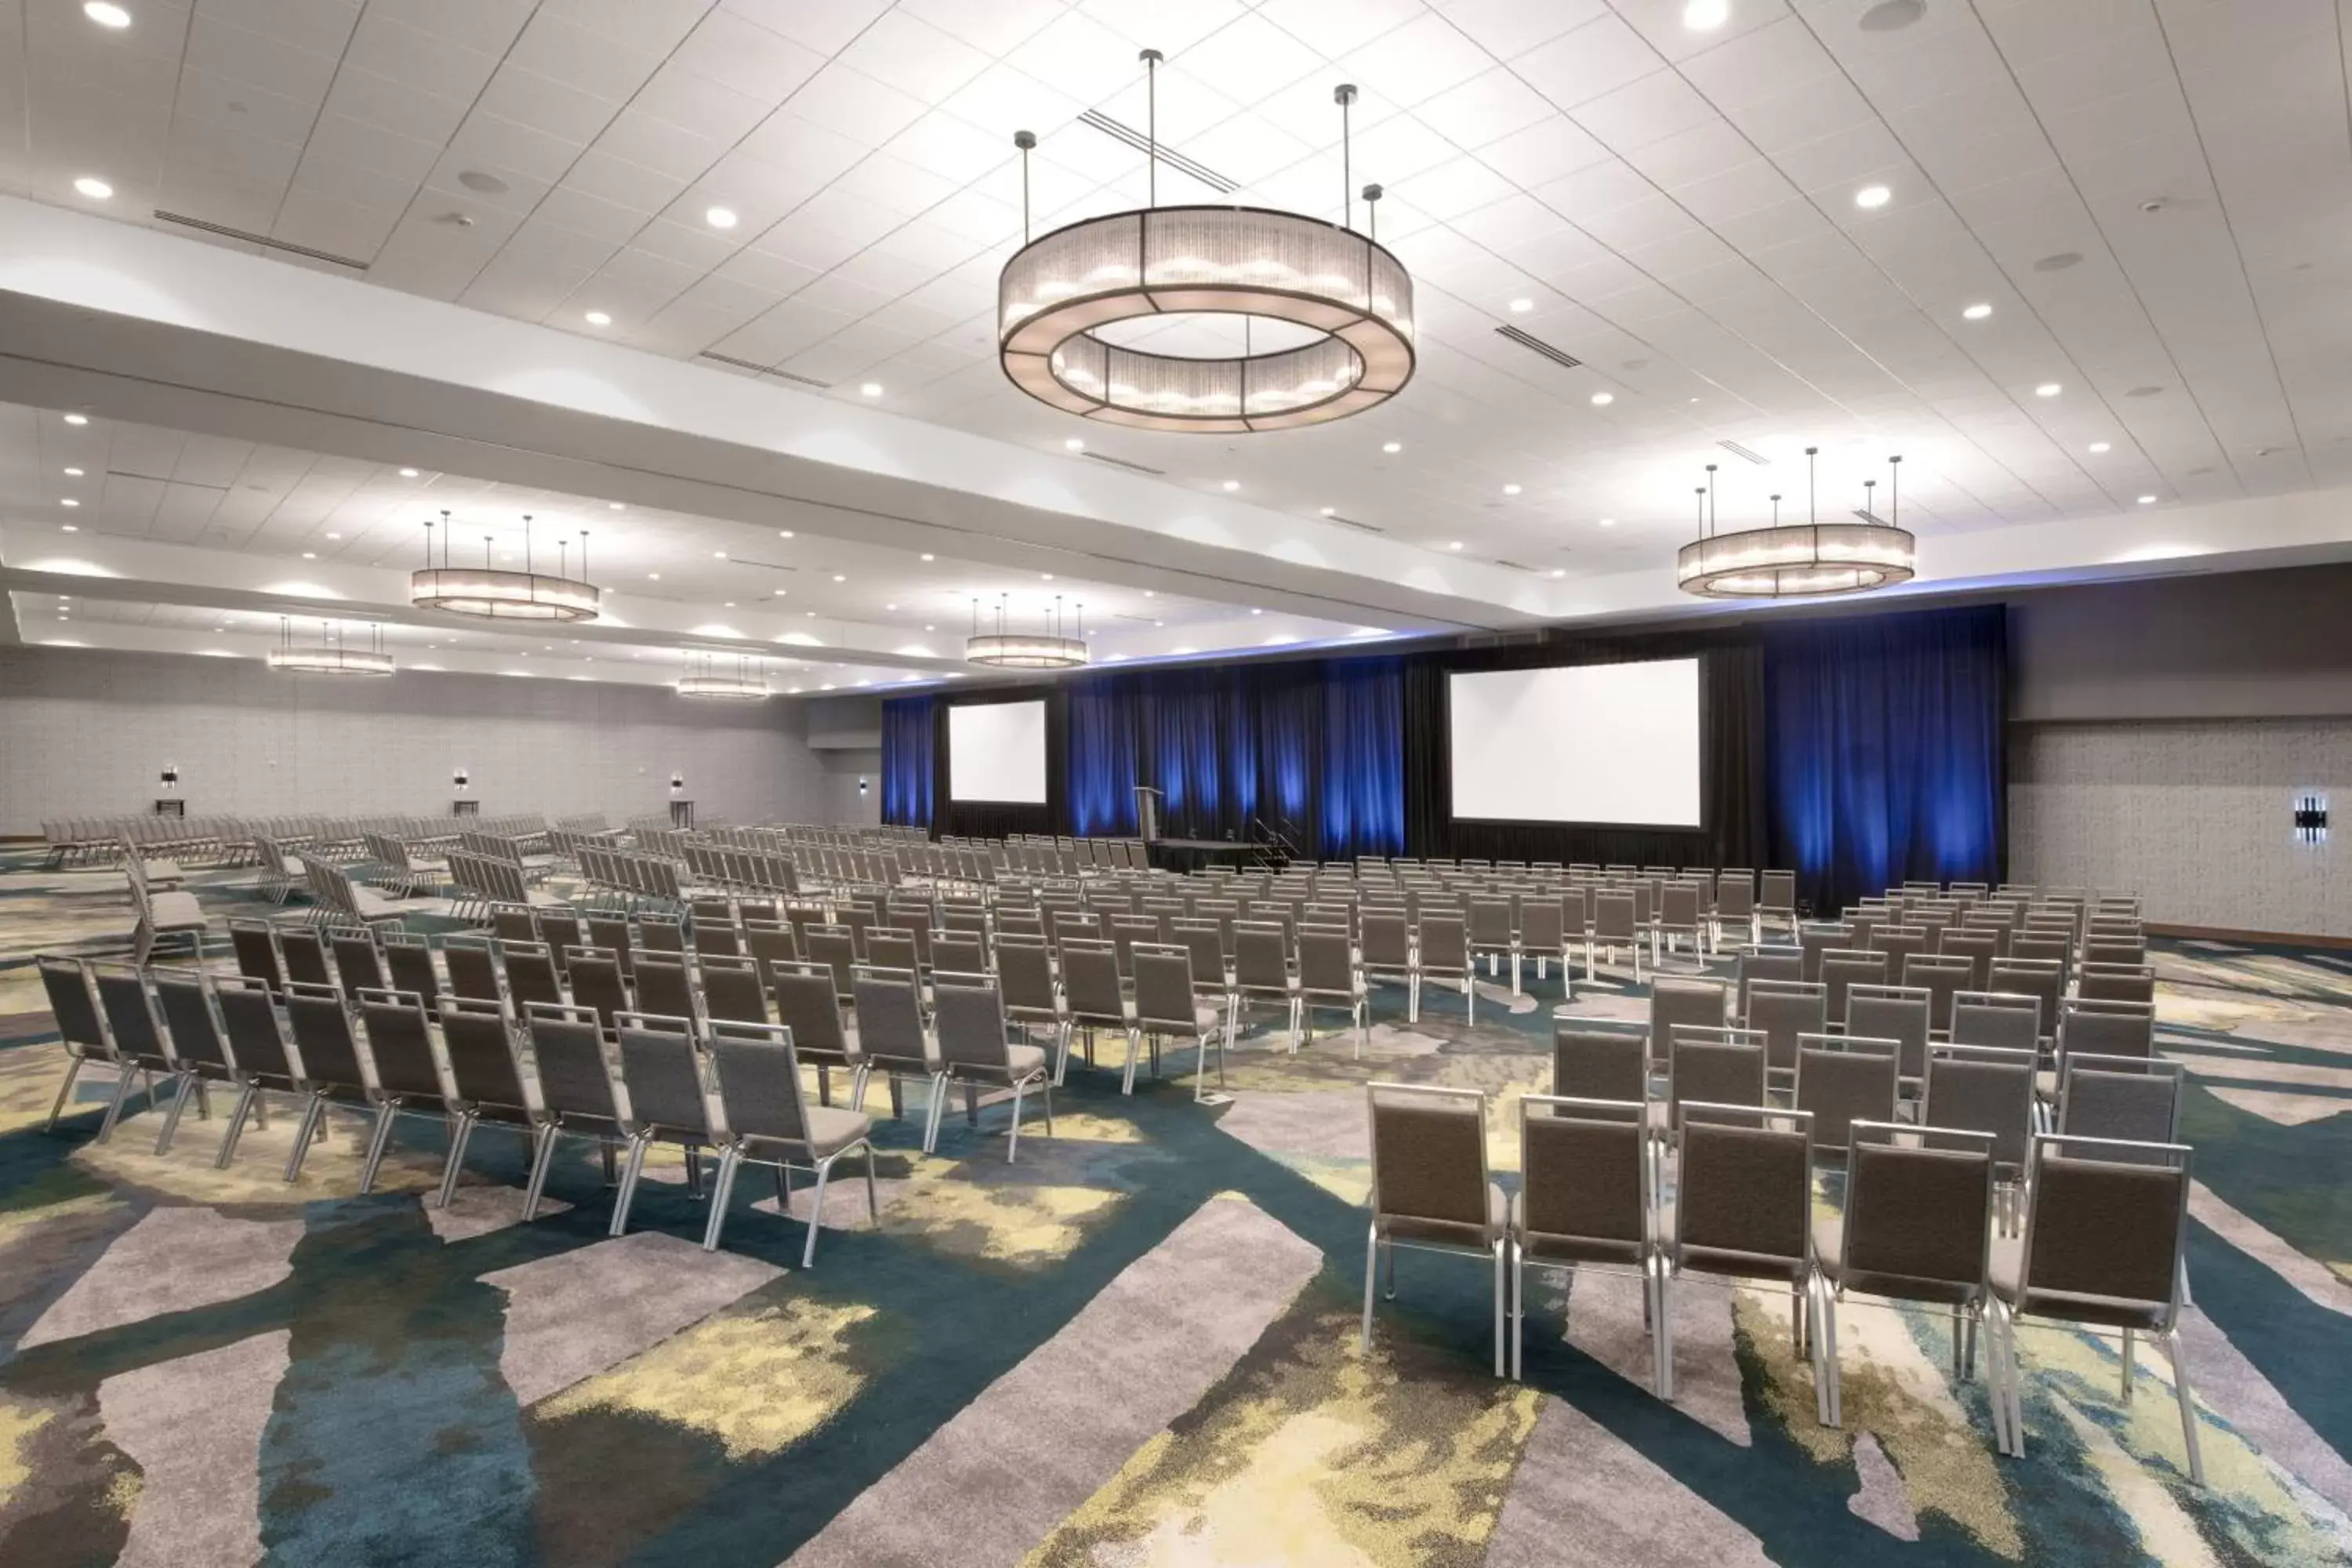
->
[[997, 49, 1414, 433]]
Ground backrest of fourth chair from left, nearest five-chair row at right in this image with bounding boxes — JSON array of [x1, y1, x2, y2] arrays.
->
[[1842, 1121, 1994, 1300]]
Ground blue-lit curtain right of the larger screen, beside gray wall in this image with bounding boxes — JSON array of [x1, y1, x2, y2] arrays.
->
[[1764, 604, 2009, 912]]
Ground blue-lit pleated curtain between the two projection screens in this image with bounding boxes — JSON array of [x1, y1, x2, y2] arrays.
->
[[1065, 659, 1404, 860]]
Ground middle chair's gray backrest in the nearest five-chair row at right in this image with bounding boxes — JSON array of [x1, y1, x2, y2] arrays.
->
[[1670, 1109, 1813, 1279]]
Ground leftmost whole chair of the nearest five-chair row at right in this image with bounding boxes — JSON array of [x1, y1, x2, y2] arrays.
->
[[1357, 1086, 1510, 1377]]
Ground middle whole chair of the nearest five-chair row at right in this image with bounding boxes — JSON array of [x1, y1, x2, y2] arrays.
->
[[1653, 1105, 1820, 1399]]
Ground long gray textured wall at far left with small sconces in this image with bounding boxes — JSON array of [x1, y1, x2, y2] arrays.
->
[[0, 647, 880, 834]]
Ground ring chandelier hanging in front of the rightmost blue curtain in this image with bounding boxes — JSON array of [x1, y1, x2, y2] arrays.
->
[[1675, 447, 1919, 600]]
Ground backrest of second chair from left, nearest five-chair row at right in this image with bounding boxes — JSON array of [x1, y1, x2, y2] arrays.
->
[[1519, 1095, 1651, 1262]]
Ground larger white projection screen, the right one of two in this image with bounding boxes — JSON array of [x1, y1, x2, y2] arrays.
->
[[1446, 659, 1705, 827]]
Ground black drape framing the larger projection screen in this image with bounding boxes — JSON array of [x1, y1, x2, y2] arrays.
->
[[1404, 630, 1769, 865]]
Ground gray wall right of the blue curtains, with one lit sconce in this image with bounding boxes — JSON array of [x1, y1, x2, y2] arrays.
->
[[2009, 567, 2352, 935]]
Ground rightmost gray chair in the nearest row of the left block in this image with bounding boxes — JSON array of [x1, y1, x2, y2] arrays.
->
[[703, 1020, 882, 1269]]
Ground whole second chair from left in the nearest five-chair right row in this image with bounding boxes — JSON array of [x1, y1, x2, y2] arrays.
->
[[1508, 1095, 1665, 1377]]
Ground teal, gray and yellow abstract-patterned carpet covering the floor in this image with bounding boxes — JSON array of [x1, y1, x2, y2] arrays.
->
[[0, 853, 2352, 1568]]
